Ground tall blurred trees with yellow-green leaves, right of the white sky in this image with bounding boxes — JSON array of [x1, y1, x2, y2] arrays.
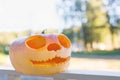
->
[[57, 0, 120, 51]]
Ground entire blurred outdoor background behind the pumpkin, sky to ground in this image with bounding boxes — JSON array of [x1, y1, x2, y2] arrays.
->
[[0, 0, 120, 71]]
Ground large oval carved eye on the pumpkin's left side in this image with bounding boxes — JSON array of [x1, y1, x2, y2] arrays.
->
[[26, 35, 46, 49]]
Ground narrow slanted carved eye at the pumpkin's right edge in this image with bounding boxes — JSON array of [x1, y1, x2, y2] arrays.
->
[[58, 35, 71, 48]]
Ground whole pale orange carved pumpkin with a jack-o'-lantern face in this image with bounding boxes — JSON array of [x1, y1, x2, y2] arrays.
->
[[9, 34, 71, 75]]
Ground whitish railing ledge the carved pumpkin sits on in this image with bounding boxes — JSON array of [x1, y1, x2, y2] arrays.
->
[[0, 67, 120, 80]]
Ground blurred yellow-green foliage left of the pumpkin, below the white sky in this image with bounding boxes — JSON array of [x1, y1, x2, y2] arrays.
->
[[0, 31, 29, 54]]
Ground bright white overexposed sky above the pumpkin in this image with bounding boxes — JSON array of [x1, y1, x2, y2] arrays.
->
[[0, 0, 63, 31]]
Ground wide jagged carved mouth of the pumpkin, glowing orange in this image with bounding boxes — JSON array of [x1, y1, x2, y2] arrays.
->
[[30, 57, 70, 65]]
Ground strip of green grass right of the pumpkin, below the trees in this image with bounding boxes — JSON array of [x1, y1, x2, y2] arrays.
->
[[72, 50, 120, 57]]
